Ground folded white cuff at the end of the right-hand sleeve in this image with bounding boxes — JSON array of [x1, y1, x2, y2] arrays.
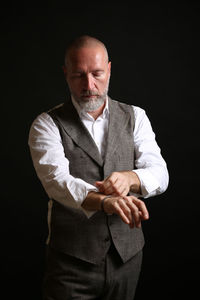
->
[[133, 169, 159, 198]]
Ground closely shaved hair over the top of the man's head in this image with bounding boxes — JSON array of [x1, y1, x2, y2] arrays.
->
[[65, 35, 109, 66]]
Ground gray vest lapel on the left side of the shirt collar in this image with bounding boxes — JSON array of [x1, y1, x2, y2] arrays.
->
[[56, 101, 103, 166]]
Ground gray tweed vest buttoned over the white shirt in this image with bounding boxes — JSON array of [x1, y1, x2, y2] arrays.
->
[[48, 98, 144, 264]]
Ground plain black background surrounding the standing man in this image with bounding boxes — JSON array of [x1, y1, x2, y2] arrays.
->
[[0, 1, 200, 300]]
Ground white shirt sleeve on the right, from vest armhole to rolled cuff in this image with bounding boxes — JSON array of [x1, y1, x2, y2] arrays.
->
[[133, 106, 169, 198]]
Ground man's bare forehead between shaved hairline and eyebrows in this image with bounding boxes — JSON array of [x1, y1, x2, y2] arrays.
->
[[67, 46, 107, 69]]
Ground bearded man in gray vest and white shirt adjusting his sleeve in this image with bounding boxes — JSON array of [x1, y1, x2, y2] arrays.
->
[[29, 36, 168, 300]]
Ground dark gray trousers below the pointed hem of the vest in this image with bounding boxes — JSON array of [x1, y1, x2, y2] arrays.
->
[[43, 246, 142, 300]]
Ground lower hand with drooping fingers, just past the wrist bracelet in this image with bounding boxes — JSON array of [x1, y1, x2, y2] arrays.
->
[[104, 196, 149, 228]]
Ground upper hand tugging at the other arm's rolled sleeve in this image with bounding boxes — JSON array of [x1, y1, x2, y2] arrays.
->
[[96, 171, 140, 197]]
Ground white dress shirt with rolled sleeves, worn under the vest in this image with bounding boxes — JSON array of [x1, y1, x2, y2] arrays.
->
[[29, 99, 169, 217]]
